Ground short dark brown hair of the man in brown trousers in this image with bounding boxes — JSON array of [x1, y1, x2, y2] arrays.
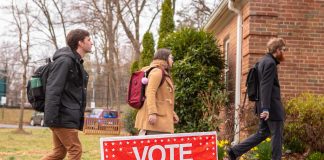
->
[[66, 29, 90, 51]]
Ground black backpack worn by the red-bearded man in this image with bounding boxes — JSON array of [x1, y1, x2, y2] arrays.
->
[[243, 63, 260, 106]]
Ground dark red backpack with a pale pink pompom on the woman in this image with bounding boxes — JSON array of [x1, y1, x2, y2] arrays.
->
[[127, 67, 165, 109]]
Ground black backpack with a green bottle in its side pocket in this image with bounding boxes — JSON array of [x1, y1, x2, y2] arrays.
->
[[27, 58, 51, 112]]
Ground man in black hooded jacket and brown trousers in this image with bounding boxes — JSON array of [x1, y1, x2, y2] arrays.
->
[[43, 29, 92, 160]]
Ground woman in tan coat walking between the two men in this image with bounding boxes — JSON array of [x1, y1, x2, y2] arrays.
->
[[135, 49, 179, 135]]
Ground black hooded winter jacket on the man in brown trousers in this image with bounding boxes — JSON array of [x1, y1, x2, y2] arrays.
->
[[44, 47, 89, 130]]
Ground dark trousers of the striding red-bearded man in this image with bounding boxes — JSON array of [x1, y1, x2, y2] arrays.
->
[[231, 120, 283, 160]]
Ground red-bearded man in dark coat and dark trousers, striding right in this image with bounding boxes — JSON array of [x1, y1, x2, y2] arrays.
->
[[228, 38, 287, 160]]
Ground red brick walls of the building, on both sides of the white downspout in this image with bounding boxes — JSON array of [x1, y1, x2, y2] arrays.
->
[[209, 0, 324, 137]]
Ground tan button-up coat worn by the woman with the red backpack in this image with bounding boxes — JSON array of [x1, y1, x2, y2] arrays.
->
[[135, 60, 177, 133]]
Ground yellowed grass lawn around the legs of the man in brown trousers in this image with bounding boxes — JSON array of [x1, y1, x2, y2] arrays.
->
[[0, 128, 116, 160]]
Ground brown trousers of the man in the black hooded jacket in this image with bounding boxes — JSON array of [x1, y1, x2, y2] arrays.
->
[[42, 128, 82, 160]]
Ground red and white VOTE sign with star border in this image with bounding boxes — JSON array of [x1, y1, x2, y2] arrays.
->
[[100, 132, 217, 160]]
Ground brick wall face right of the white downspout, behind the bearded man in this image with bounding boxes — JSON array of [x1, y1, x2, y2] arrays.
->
[[247, 0, 324, 99]]
